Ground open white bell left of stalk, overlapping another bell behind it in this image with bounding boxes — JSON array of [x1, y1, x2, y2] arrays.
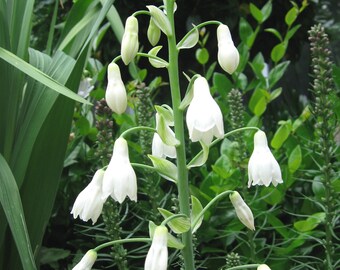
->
[[102, 138, 137, 203]]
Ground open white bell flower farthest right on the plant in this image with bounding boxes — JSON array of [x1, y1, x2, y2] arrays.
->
[[248, 130, 283, 187]]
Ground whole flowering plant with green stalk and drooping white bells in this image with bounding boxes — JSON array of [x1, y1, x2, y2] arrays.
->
[[72, 0, 282, 270]]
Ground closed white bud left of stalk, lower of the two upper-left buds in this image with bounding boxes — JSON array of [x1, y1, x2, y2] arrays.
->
[[105, 63, 127, 114]]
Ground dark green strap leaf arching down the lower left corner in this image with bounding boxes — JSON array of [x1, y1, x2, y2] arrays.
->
[[0, 154, 37, 270]]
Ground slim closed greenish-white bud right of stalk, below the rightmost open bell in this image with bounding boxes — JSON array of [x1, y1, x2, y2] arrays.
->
[[229, 191, 255, 231]]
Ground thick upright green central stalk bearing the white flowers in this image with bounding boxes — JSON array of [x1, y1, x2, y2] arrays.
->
[[166, 0, 195, 270]]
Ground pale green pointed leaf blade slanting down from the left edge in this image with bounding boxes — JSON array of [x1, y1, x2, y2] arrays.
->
[[0, 48, 91, 104]]
